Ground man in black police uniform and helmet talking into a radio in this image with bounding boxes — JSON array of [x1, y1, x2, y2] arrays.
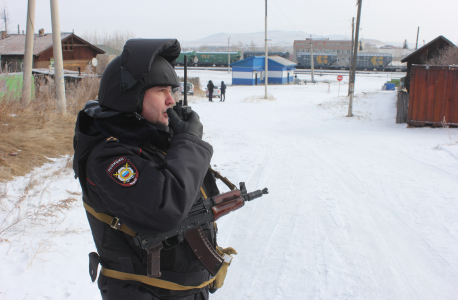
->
[[73, 39, 219, 300]]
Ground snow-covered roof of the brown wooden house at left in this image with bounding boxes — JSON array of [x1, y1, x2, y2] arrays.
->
[[0, 32, 104, 55]]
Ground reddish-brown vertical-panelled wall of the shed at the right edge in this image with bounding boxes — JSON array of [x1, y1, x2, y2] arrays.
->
[[407, 65, 458, 126]]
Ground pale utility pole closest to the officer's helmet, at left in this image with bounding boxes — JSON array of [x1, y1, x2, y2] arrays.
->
[[51, 0, 66, 113]]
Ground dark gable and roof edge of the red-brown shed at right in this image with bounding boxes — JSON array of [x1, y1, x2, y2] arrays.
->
[[401, 35, 455, 91]]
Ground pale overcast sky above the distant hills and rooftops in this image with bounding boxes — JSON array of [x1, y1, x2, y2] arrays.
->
[[0, 0, 458, 48]]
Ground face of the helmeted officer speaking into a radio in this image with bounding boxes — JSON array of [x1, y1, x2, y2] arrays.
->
[[140, 86, 175, 126]]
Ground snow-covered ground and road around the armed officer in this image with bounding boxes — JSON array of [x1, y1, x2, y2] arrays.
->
[[0, 71, 458, 300]]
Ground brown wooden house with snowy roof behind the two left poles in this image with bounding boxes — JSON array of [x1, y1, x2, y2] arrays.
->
[[0, 30, 105, 72]]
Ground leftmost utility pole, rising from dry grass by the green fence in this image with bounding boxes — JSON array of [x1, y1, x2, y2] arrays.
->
[[22, 0, 35, 104]]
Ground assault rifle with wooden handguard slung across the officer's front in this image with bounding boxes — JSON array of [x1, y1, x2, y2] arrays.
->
[[134, 182, 269, 277]]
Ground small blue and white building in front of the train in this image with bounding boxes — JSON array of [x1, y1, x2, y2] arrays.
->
[[231, 56, 296, 85]]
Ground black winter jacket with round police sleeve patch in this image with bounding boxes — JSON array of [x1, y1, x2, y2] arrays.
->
[[74, 107, 219, 298]]
